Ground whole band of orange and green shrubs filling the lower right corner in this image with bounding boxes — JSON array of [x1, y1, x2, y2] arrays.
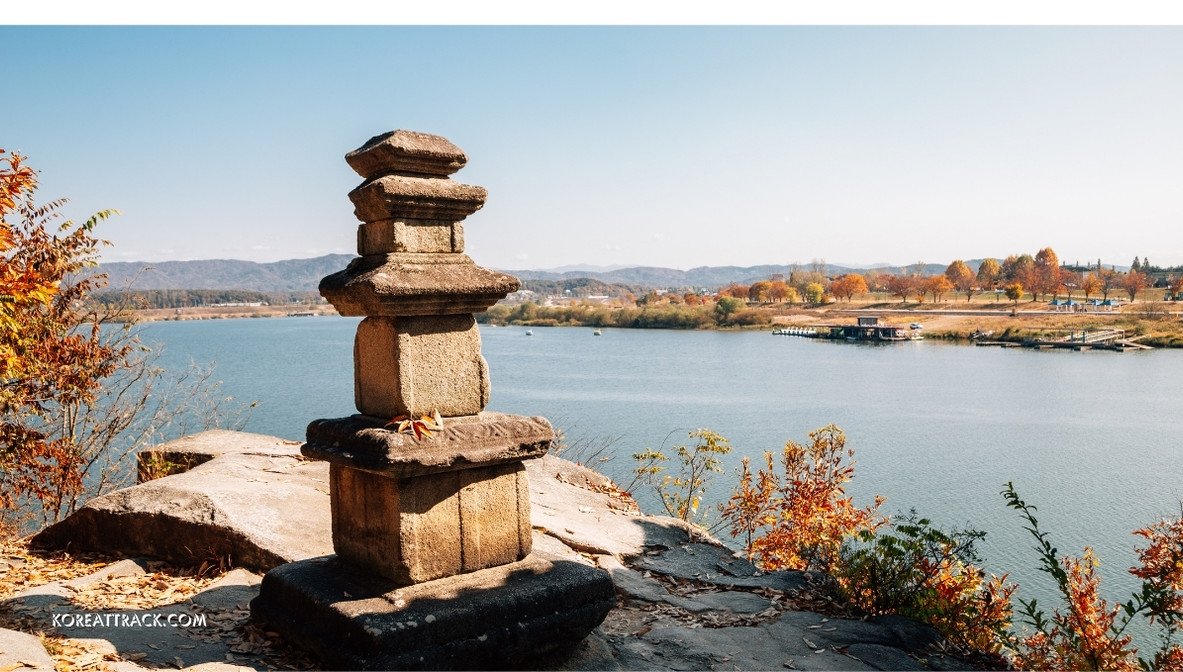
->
[[705, 425, 1183, 670]]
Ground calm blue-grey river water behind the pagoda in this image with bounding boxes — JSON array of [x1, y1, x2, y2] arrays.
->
[[143, 317, 1183, 634]]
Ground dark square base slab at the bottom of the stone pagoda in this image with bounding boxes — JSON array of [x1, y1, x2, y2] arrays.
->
[[251, 556, 616, 670]]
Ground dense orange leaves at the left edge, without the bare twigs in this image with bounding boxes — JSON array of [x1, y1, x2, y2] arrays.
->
[[0, 154, 126, 518]]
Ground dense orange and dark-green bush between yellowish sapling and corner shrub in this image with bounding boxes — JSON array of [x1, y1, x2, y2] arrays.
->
[[723, 425, 1015, 652]]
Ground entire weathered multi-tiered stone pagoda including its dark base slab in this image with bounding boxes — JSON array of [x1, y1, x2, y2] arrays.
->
[[251, 130, 615, 670]]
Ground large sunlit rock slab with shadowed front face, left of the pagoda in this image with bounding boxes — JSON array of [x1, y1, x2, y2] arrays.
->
[[32, 432, 332, 570]]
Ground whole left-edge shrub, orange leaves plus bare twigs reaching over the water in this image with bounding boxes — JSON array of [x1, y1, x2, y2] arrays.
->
[[0, 150, 251, 529]]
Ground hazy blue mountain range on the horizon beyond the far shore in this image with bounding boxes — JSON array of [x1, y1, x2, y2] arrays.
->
[[89, 254, 960, 292]]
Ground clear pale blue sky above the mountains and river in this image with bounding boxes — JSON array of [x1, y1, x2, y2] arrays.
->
[[0, 26, 1183, 269]]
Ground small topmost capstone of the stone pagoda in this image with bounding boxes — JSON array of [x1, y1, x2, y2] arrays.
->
[[345, 130, 468, 180]]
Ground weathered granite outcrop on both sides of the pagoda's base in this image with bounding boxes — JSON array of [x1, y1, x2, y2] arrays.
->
[[23, 432, 968, 672]]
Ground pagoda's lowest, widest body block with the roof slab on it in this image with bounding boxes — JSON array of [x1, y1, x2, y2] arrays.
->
[[302, 413, 554, 584]]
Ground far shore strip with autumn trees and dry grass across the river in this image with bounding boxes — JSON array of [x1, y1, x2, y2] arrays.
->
[[104, 247, 1183, 348]]
